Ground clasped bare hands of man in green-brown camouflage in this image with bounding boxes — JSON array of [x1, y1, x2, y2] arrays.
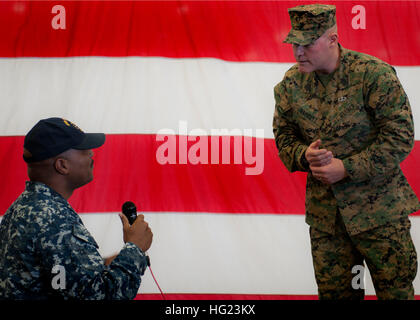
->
[[305, 139, 348, 184]]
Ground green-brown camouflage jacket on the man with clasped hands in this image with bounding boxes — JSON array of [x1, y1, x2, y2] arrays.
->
[[273, 45, 420, 235]]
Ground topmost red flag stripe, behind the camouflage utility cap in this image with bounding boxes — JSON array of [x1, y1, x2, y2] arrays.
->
[[0, 1, 420, 65]]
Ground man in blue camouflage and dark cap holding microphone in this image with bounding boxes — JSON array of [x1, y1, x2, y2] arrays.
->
[[0, 118, 153, 300]]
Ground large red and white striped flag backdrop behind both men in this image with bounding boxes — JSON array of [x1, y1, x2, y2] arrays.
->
[[0, 1, 420, 299]]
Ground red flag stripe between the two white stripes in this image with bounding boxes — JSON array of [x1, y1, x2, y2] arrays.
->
[[0, 134, 420, 214]]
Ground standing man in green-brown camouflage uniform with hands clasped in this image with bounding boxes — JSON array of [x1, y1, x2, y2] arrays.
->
[[273, 5, 420, 299]]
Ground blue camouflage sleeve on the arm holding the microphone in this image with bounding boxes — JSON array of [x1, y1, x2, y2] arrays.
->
[[38, 212, 147, 300]]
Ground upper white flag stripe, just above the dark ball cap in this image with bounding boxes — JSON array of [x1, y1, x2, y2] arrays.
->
[[0, 57, 420, 139]]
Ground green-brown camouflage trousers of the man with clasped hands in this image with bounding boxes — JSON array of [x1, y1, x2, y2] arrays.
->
[[310, 213, 417, 300]]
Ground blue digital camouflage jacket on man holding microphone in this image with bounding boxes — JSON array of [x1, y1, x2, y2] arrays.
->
[[0, 181, 146, 300]]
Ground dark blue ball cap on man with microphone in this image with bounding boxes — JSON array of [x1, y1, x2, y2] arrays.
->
[[23, 118, 105, 163]]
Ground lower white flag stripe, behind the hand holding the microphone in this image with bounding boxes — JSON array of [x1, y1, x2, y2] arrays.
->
[[74, 212, 420, 295]]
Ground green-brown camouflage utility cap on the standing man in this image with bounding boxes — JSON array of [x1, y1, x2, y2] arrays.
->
[[284, 4, 336, 46]]
